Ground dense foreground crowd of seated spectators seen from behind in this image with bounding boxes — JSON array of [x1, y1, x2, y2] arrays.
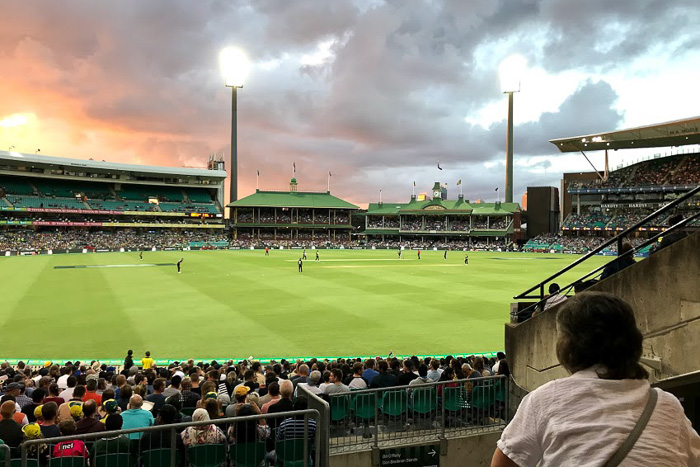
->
[[0, 350, 510, 460]]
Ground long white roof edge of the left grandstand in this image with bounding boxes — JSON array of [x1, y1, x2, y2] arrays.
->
[[0, 151, 226, 179]]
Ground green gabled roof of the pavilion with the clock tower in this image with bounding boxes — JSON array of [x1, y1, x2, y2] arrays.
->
[[365, 199, 520, 216]]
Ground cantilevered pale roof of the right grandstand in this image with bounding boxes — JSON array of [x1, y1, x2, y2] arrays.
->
[[549, 117, 700, 152]]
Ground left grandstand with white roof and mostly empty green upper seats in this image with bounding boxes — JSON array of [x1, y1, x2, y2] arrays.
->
[[0, 151, 226, 243]]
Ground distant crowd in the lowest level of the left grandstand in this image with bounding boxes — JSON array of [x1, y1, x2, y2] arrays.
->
[[0, 229, 228, 251]]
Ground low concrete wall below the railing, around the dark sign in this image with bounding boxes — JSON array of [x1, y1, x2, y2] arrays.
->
[[330, 432, 501, 467]]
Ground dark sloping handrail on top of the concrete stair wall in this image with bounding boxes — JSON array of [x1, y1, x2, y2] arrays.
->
[[513, 186, 700, 315]]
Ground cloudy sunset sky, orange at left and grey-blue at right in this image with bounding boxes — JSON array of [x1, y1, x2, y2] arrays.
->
[[0, 0, 700, 207]]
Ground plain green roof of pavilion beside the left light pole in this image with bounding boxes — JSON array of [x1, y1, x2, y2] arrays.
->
[[227, 190, 360, 209]]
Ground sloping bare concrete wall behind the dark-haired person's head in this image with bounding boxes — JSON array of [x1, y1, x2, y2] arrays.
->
[[505, 232, 700, 391]]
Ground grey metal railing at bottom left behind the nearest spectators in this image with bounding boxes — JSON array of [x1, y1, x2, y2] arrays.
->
[[13, 409, 320, 467]]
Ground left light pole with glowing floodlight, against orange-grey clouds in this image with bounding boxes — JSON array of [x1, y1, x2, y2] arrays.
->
[[219, 47, 250, 218]]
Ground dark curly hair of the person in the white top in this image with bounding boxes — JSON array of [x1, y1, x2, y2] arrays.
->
[[557, 292, 649, 379]]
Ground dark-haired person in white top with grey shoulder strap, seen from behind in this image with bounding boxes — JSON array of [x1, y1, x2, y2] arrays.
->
[[491, 292, 700, 466]]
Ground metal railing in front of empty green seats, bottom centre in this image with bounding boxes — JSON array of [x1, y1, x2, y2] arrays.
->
[[299, 376, 509, 454]]
